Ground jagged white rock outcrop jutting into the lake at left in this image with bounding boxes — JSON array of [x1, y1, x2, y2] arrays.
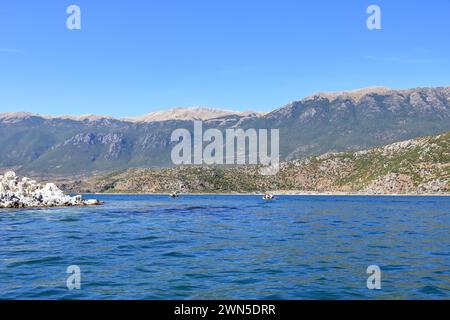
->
[[0, 171, 102, 208]]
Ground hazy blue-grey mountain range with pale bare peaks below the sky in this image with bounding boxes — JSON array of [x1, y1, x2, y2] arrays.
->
[[0, 87, 450, 174]]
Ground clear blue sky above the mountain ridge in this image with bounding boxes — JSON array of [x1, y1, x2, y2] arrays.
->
[[0, 0, 450, 116]]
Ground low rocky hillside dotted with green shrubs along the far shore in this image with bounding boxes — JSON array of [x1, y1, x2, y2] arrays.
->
[[63, 132, 450, 194]]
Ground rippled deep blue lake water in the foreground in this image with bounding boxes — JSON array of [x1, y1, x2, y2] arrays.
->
[[0, 195, 450, 299]]
